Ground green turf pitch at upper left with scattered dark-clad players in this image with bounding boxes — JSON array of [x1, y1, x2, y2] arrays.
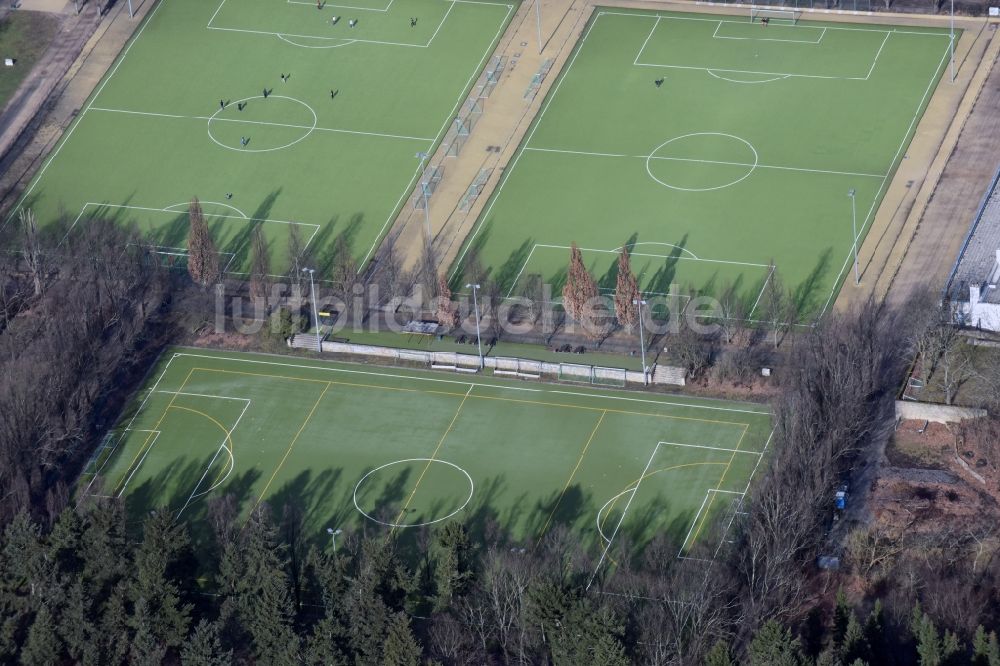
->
[[0, 0, 514, 274]]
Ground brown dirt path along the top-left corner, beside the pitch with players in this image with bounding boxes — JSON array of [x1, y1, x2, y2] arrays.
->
[[0, 0, 154, 218]]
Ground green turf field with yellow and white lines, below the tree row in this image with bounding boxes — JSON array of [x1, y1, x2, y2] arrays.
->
[[80, 349, 770, 556]]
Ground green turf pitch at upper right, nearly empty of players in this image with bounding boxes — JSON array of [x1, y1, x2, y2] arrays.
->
[[453, 10, 950, 319]]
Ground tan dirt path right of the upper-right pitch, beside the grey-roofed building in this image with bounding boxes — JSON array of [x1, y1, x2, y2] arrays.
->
[[836, 20, 1000, 308]]
